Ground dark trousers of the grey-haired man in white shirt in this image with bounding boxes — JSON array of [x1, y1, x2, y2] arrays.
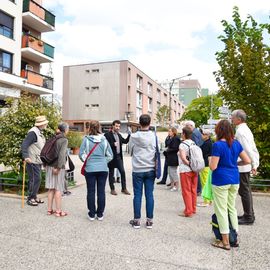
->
[[238, 172, 255, 220]]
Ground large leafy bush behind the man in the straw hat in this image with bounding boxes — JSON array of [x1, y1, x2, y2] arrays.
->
[[0, 95, 61, 171]]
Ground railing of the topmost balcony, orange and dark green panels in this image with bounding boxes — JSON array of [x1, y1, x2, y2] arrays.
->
[[23, 0, 55, 27]]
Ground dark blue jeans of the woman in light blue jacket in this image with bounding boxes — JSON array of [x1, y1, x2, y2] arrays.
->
[[85, 172, 108, 218]]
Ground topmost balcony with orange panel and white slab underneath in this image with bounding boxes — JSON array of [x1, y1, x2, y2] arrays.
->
[[23, 0, 55, 33]]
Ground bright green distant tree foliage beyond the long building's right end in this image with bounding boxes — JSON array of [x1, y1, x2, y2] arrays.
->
[[178, 95, 222, 126]]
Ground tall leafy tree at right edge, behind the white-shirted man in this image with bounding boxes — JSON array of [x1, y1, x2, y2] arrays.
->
[[214, 7, 270, 177]]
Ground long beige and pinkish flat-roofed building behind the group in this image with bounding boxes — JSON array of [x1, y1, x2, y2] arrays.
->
[[63, 60, 185, 131]]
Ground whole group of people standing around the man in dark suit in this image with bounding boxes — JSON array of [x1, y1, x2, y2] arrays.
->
[[22, 110, 259, 250]]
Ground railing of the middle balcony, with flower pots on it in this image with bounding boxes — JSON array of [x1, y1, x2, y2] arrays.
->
[[22, 35, 54, 58]]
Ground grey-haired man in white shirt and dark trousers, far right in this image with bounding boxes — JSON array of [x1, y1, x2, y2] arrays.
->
[[232, 110, 259, 225]]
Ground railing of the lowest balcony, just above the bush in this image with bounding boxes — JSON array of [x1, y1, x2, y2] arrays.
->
[[21, 69, 53, 90]]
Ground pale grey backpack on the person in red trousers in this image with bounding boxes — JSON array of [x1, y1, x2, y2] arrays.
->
[[183, 142, 205, 173]]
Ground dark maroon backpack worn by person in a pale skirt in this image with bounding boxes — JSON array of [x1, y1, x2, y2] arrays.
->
[[40, 134, 63, 165]]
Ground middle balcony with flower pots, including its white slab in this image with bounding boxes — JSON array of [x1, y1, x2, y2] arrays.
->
[[22, 35, 54, 64]]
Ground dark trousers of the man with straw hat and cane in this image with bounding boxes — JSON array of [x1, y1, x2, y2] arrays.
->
[[26, 163, 41, 200]]
